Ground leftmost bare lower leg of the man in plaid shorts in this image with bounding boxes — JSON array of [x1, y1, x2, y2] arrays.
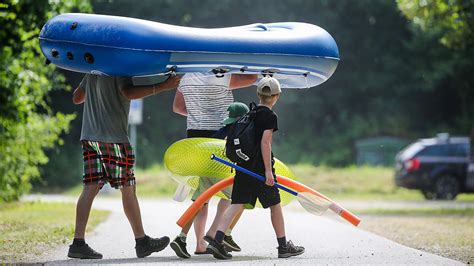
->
[[74, 184, 100, 239]]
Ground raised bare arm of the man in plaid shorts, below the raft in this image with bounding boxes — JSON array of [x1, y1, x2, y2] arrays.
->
[[122, 76, 181, 100]]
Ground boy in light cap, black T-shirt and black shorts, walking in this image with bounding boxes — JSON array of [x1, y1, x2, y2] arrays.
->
[[207, 77, 305, 259]]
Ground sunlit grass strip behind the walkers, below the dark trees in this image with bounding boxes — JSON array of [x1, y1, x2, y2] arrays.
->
[[67, 164, 474, 201]]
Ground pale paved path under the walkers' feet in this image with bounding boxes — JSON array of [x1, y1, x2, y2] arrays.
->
[[30, 194, 462, 265]]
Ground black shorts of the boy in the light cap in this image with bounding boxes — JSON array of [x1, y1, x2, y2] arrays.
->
[[231, 169, 281, 208]]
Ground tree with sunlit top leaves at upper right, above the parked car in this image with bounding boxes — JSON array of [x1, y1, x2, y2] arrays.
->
[[397, 0, 474, 135]]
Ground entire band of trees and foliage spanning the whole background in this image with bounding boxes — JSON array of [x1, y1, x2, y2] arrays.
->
[[0, 0, 474, 195]]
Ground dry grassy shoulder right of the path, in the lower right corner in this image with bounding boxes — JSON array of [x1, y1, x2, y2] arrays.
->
[[360, 214, 474, 264]]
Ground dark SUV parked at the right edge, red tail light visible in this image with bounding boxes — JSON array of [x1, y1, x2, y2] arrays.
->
[[395, 133, 474, 199]]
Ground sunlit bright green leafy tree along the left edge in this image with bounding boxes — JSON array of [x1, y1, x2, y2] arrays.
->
[[0, 0, 91, 201]]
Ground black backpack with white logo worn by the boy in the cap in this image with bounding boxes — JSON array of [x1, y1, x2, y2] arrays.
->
[[225, 103, 260, 163]]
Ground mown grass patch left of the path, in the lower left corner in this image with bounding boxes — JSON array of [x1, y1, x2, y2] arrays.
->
[[0, 202, 109, 262]]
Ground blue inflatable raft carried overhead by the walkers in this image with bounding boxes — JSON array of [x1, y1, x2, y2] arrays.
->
[[39, 13, 339, 88]]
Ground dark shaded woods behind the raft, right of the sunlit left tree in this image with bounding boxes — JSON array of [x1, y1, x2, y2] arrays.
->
[[75, 0, 474, 166]]
